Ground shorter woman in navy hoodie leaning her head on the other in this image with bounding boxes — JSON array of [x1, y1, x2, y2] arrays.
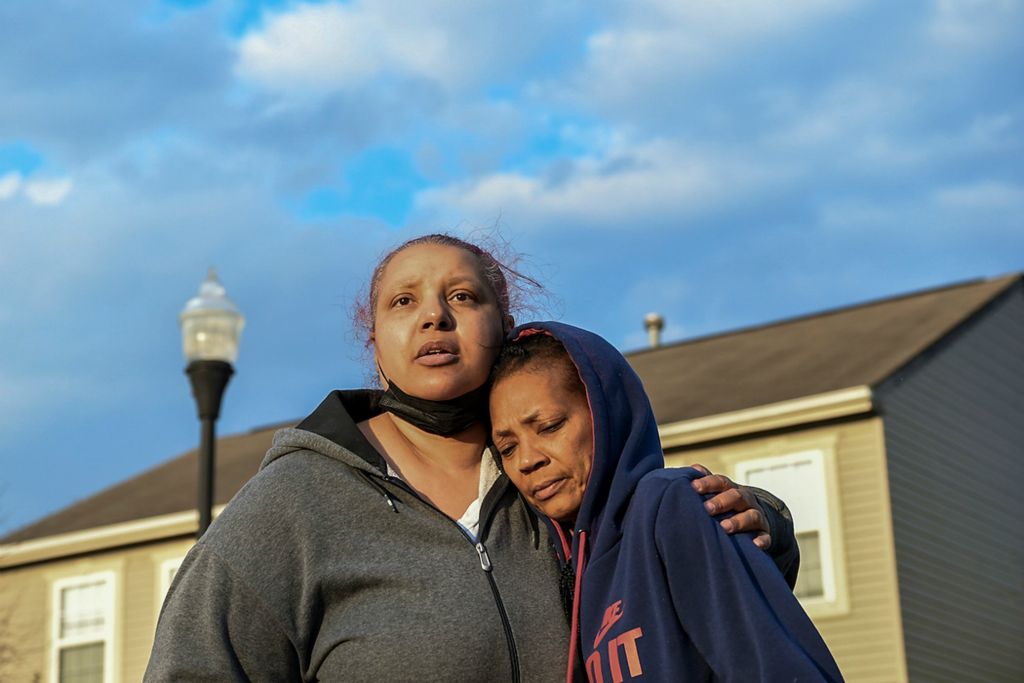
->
[[490, 323, 842, 683]]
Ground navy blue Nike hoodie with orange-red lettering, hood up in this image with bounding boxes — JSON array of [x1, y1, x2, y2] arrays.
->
[[513, 323, 842, 683]]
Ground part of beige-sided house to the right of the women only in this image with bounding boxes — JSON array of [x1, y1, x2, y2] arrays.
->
[[630, 274, 1024, 683]]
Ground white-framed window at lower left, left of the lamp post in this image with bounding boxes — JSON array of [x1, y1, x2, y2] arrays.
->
[[51, 571, 115, 683]]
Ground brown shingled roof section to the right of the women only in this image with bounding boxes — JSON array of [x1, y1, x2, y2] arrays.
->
[[627, 273, 1021, 424]]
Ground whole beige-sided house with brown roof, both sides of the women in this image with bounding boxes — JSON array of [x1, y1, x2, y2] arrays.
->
[[0, 275, 1024, 682]]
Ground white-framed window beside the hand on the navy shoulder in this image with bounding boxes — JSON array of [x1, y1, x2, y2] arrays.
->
[[734, 449, 846, 608]]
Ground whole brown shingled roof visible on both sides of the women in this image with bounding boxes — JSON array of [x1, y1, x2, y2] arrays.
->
[[0, 274, 1022, 543]]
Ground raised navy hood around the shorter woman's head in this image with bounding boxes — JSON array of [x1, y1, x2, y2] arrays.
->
[[512, 322, 665, 557]]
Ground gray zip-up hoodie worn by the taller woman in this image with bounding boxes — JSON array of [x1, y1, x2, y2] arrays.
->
[[145, 391, 568, 682]]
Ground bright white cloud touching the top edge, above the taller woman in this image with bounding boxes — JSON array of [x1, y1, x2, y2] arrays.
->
[[236, 0, 586, 95]]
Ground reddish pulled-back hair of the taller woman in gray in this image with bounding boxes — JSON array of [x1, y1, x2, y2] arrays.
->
[[353, 232, 544, 346]]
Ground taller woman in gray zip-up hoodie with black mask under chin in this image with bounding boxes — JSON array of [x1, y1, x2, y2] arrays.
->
[[145, 236, 793, 681]]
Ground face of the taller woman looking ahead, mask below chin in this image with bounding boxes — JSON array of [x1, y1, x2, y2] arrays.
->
[[373, 245, 503, 400]]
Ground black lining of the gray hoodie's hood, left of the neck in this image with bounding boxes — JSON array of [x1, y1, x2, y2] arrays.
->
[[295, 389, 387, 475]]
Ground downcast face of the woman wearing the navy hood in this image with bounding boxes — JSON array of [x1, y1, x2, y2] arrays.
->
[[490, 369, 594, 523]]
